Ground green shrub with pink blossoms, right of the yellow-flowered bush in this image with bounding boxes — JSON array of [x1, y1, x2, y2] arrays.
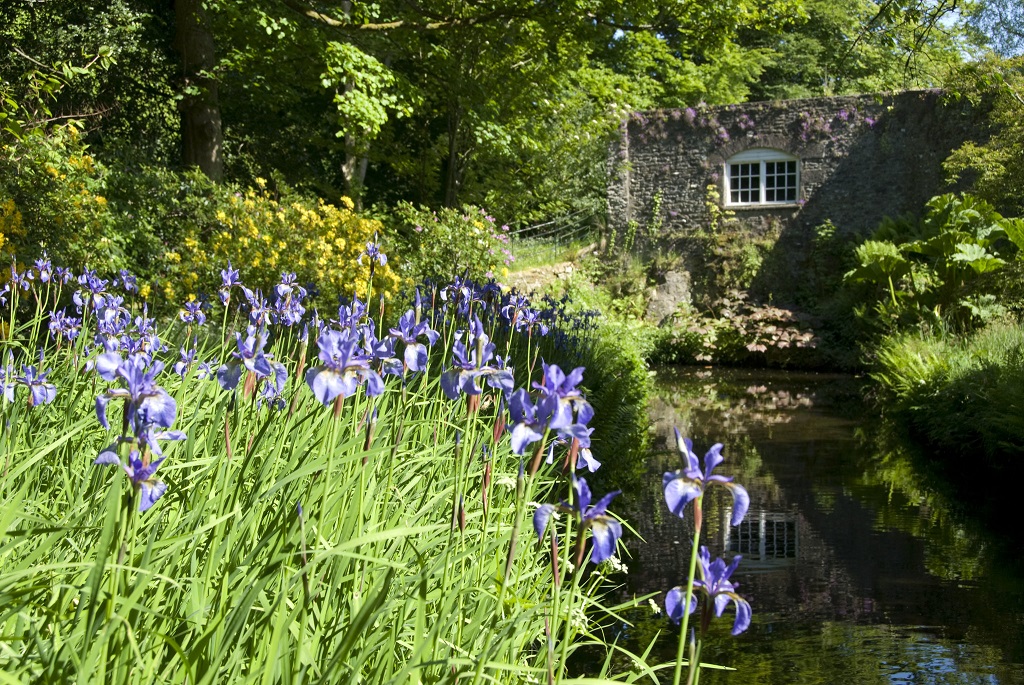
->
[[386, 203, 515, 282]]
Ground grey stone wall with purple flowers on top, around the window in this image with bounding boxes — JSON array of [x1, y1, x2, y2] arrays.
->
[[608, 91, 978, 302]]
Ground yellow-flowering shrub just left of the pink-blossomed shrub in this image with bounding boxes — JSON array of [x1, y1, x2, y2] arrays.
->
[[163, 187, 402, 305]]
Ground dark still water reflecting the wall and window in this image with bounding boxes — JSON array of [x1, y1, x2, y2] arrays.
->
[[620, 370, 1024, 685]]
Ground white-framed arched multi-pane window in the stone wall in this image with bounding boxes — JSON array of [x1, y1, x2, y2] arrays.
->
[[725, 147, 800, 206]]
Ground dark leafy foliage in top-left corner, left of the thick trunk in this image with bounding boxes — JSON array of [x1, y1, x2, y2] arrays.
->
[[0, 0, 180, 165]]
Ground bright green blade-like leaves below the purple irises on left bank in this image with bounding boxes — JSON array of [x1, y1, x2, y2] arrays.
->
[[0, 276, 656, 684]]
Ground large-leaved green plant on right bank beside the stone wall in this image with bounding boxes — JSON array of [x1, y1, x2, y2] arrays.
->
[[846, 195, 1024, 329]]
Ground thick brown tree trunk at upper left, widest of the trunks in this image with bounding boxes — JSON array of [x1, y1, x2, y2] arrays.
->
[[174, 0, 224, 180]]
